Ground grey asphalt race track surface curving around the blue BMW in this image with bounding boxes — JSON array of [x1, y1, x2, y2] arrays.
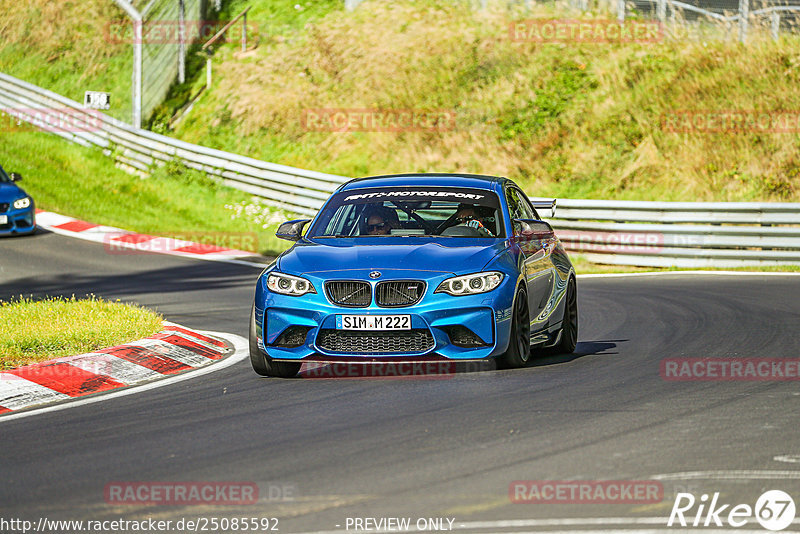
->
[[0, 228, 800, 533]]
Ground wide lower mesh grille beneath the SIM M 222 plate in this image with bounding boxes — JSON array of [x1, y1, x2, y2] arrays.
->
[[317, 328, 434, 354]]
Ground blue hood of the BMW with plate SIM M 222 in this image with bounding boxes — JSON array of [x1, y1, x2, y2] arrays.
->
[[278, 237, 506, 274]]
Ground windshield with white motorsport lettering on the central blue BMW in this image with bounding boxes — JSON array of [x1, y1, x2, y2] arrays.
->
[[308, 187, 504, 239]]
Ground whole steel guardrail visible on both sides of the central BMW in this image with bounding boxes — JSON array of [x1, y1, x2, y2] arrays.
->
[[0, 73, 800, 267]]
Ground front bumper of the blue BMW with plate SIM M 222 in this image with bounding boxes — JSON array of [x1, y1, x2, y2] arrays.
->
[[255, 272, 516, 362]]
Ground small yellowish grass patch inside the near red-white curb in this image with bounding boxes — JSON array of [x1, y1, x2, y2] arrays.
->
[[0, 296, 162, 369]]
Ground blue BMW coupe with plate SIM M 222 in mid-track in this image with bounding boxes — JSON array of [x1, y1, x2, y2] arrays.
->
[[250, 174, 578, 377]]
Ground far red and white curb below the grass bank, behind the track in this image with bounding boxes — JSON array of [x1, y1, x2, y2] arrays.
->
[[36, 210, 260, 263]]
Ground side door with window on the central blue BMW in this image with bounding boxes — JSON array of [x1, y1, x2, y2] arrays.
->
[[506, 185, 554, 326]]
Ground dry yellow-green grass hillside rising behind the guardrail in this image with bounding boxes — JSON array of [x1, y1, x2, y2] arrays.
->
[[167, 0, 800, 201]]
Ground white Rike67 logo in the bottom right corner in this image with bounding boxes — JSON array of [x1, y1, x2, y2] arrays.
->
[[667, 490, 795, 531]]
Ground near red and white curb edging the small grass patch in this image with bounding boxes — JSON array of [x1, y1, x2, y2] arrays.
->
[[0, 321, 235, 414]]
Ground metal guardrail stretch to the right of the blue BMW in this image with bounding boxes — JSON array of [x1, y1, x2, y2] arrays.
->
[[540, 199, 800, 267]]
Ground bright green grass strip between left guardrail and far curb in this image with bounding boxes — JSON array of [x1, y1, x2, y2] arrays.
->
[[0, 132, 293, 255]]
